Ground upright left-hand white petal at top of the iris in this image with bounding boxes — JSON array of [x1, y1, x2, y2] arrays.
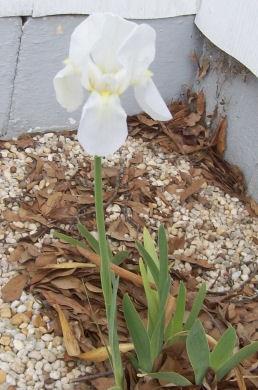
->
[[69, 14, 105, 67]]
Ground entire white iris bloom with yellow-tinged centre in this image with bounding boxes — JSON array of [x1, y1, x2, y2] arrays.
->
[[54, 13, 171, 156]]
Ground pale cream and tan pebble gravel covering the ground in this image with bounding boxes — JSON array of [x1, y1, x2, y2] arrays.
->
[[0, 133, 258, 390]]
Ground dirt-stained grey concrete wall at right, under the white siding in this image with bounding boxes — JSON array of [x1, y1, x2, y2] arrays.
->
[[195, 40, 258, 201]]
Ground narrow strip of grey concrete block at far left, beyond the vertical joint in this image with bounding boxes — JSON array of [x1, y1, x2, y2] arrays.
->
[[0, 18, 22, 135]]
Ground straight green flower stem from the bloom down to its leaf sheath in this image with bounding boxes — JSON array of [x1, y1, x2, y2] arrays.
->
[[94, 156, 112, 319]]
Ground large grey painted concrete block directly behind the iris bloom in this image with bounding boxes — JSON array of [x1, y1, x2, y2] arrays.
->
[[8, 16, 202, 136]]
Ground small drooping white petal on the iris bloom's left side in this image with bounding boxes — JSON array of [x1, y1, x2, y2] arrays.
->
[[54, 65, 83, 112]]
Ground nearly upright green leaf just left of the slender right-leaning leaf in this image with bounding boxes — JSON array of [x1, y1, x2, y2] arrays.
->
[[166, 282, 186, 341]]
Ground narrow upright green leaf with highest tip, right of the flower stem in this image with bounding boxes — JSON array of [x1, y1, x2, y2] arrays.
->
[[158, 225, 169, 293]]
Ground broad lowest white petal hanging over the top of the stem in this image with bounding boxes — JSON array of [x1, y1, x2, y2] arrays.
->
[[78, 92, 128, 156]]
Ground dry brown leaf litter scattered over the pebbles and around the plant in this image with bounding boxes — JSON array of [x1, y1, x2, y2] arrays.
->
[[1, 90, 258, 390]]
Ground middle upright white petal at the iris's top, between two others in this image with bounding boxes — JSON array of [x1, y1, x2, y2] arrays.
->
[[91, 13, 136, 73]]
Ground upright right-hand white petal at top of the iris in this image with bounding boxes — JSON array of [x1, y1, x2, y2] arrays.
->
[[118, 24, 156, 82]]
